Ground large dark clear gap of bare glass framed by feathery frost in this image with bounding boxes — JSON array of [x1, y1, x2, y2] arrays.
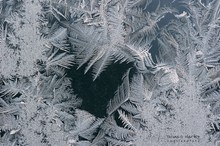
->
[[67, 63, 131, 117]]
